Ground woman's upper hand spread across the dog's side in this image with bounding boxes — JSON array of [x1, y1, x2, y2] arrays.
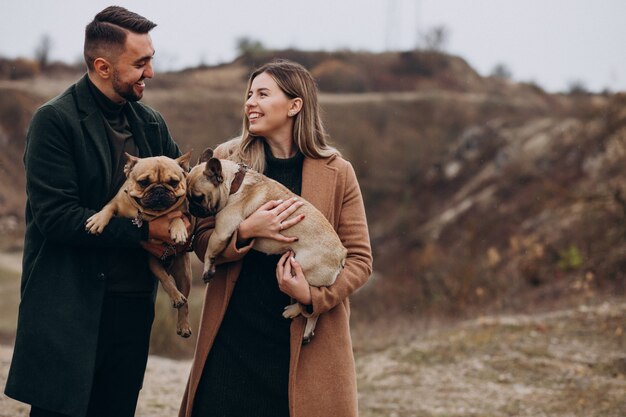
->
[[237, 197, 304, 243]]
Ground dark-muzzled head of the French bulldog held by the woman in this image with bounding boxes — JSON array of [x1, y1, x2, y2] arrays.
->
[[187, 149, 228, 217]]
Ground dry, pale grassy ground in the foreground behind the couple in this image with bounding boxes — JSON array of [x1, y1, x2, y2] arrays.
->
[[0, 301, 626, 417]]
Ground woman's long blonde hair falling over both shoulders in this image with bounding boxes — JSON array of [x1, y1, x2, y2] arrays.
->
[[225, 60, 340, 172]]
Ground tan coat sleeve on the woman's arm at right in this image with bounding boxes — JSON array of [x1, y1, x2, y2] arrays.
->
[[304, 163, 372, 317]]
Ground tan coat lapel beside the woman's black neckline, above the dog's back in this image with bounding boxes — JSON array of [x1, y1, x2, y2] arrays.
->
[[302, 157, 337, 224]]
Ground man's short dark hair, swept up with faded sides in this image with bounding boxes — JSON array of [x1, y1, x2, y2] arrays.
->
[[84, 6, 156, 71]]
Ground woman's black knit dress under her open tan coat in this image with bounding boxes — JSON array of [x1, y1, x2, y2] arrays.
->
[[192, 146, 304, 417]]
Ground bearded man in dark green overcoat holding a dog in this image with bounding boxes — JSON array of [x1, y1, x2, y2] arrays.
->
[[5, 7, 186, 417]]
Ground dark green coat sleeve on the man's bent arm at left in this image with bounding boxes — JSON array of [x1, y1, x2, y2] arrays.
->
[[24, 106, 147, 247]]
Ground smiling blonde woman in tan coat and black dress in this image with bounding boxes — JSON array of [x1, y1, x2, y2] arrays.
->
[[180, 60, 372, 417]]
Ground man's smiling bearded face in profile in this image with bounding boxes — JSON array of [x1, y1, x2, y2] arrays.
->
[[111, 32, 154, 102]]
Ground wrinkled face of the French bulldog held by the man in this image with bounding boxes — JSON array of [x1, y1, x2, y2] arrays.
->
[[124, 152, 191, 212]]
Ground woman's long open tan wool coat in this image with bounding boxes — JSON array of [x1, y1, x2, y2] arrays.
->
[[179, 148, 372, 417]]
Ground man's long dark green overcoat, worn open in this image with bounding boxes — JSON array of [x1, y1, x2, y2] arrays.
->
[[5, 75, 180, 417]]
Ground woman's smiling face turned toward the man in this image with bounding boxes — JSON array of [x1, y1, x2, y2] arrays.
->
[[245, 72, 297, 140]]
